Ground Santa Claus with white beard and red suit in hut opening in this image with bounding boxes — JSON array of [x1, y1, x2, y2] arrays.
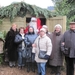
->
[[25, 17, 42, 34]]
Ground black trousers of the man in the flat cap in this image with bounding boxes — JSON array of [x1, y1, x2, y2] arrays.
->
[[65, 57, 75, 75]]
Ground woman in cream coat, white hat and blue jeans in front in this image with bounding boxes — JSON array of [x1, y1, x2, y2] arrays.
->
[[32, 28, 52, 75]]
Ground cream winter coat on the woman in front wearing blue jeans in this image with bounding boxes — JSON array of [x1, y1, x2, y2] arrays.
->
[[32, 34, 52, 63]]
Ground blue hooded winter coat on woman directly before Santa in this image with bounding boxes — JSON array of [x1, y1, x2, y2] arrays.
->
[[25, 33, 38, 62]]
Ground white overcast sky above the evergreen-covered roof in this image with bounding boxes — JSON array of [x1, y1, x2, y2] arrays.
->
[[0, 0, 54, 8]]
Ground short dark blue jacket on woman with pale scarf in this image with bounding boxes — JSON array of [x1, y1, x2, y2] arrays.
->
[[15, 34, 25, 51]]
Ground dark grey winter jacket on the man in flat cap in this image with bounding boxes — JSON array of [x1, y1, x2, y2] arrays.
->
[[61, 30, 75, 58]]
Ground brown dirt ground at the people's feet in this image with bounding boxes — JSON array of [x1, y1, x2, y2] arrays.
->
[[0, 65, 66, 75]]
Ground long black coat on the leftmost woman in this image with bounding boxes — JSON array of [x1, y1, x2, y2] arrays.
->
[[4, 29, 18, 61]]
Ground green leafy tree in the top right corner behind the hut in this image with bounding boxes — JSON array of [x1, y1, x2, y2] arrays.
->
[[52, 0, 75, 28]]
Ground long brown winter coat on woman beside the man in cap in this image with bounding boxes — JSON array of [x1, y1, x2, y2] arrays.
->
[[49, 32, 63, 66]]
